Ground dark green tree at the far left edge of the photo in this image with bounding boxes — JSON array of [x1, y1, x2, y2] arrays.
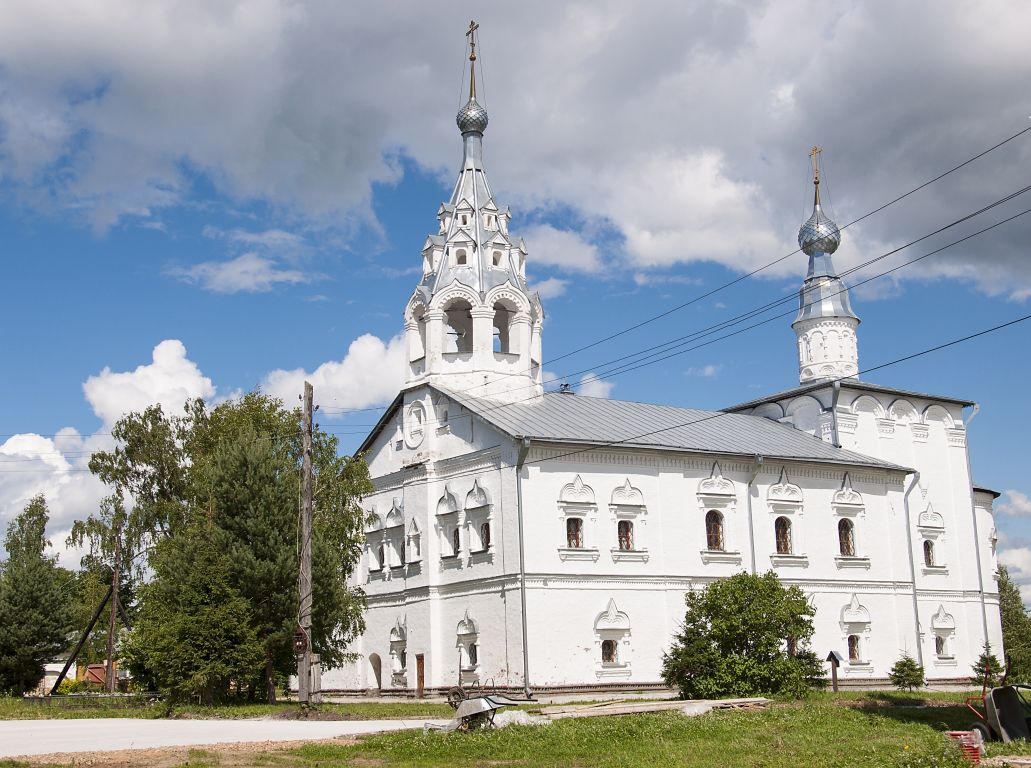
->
[[0, 496, 71, 694]]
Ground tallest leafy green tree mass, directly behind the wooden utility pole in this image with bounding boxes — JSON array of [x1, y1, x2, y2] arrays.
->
[[81, 393, 372, 700]]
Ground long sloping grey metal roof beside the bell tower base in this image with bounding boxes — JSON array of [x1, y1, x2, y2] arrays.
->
[[435, 388, 905, 471]]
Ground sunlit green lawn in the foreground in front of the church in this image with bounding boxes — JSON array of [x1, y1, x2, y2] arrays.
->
[[294, 701, 964, 768]]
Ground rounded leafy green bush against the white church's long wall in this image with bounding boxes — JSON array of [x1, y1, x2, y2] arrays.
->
[[663, 571, 823, 699]]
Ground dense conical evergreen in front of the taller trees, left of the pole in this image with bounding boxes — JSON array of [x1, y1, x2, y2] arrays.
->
[[122, 517, 264, 704]]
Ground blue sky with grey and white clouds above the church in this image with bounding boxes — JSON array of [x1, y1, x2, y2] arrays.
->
[[0, 0, 1031, 602]]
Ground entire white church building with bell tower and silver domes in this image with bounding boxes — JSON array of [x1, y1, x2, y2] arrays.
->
[[324, 29, 1002, 693]]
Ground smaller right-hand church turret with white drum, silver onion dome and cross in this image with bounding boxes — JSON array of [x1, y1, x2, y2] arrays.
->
[[791, 146, 859, 383]]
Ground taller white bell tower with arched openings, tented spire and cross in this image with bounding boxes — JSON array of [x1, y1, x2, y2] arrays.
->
[[404, 22, 544, 402]]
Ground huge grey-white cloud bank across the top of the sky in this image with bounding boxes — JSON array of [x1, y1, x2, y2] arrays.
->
[[0, 0, 1031, 292]]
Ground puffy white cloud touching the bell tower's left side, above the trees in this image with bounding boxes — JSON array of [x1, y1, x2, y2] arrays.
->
[[262, 334, 406, 408]]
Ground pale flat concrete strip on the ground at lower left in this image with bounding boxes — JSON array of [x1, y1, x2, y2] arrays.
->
[[0, 717, 446, 758]]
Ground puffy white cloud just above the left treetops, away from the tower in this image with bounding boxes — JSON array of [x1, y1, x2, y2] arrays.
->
[[82, 339, 214, 426]]
